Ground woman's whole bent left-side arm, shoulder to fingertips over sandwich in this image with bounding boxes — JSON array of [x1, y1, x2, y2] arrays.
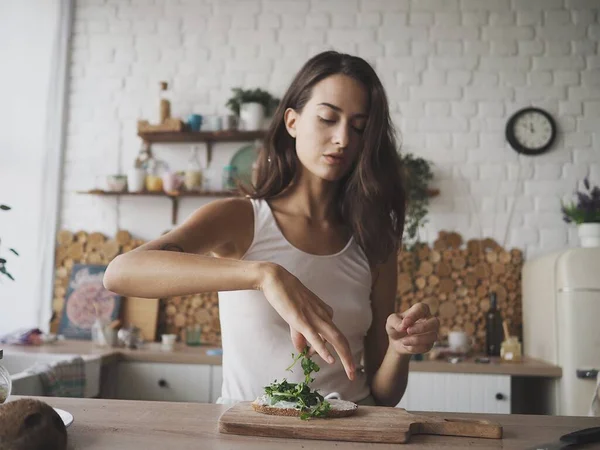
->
[[104, 199, 355, 379]]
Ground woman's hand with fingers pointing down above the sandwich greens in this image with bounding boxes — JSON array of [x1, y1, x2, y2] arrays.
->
[[260, 263, 355, 380]]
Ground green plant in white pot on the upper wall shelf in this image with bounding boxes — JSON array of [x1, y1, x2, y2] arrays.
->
[[226, 87, 279, 131]]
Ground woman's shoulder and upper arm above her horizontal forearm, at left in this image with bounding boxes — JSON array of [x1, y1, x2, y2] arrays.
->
[[132, 197, 254, 258]]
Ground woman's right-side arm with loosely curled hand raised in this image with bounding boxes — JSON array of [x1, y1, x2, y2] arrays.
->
[[365, 251, 439, 406]]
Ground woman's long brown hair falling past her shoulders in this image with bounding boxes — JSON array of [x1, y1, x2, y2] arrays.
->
[[248, 51, 406, 264]]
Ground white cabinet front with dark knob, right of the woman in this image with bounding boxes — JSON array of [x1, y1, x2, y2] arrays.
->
[[398, 372, 511, 414]]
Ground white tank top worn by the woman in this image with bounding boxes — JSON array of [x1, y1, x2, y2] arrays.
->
[[219, 199, 372, 402]]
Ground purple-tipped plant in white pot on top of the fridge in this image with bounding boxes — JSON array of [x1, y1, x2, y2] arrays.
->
[[561, 177, 600, 247]]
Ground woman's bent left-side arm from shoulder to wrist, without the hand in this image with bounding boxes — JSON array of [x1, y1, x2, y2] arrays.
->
[[104, 199, 267, 298]]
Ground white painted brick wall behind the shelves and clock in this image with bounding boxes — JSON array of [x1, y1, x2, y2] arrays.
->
[[61, 0, 600, 257]]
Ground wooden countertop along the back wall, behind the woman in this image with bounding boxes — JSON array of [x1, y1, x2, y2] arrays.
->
[[3, 340, 562, 378]]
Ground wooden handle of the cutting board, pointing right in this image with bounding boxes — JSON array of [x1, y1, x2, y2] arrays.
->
[[411, 417, 502, 439]]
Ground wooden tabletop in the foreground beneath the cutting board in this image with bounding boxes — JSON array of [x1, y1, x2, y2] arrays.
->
[[15, 397, 599, 450]]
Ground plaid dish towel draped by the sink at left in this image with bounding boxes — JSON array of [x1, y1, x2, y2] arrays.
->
[[31, 356, 85, 397]]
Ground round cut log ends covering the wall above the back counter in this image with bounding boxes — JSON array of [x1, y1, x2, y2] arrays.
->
[[56, 230, 523, 351]]
